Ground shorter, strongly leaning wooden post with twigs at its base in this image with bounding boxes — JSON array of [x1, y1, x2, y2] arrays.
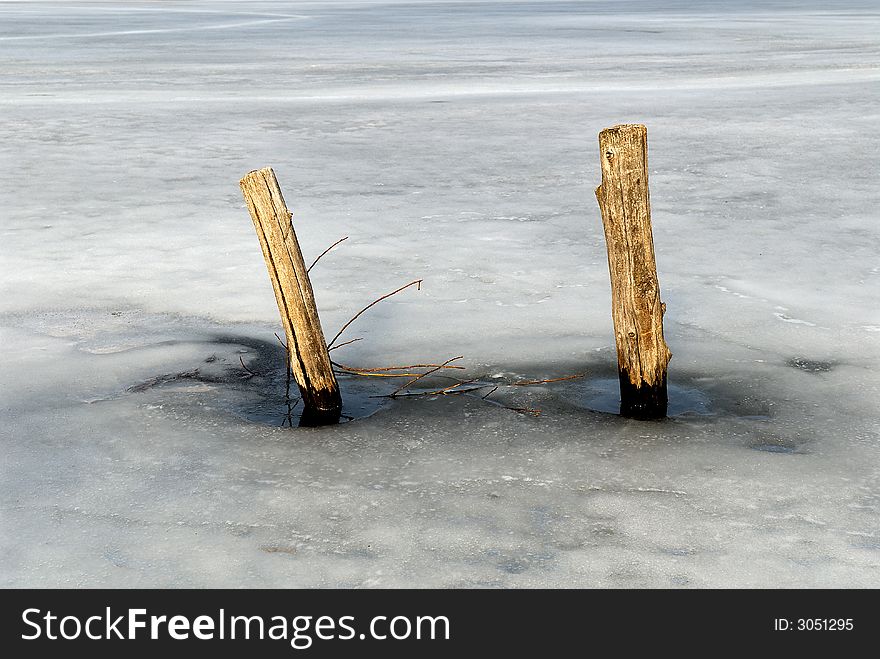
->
[[240, 167, 342, 426]]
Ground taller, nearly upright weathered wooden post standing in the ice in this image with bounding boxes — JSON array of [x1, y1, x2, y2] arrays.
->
[[596, 124, 672, 419]]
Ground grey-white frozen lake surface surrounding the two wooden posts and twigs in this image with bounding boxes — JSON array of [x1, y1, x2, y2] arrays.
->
[[0, 0, 880, 588]]
